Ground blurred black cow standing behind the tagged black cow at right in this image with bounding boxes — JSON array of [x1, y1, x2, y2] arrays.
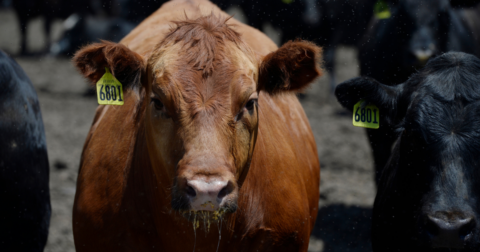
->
[[359, 0, 480, 184]]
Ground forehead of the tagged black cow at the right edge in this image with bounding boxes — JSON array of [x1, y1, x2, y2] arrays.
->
[[405, 53, 480, 140]]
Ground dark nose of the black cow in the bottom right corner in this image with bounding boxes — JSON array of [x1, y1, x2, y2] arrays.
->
[[427, 214, 476, 249]]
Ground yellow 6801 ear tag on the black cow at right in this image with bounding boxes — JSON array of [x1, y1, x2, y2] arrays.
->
[[353, 100, 380, 129]]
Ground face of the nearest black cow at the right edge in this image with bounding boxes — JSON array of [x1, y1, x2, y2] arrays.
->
[[394, 92, 480, 250]]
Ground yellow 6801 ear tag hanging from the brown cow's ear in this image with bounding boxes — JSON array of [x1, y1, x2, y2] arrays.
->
[[97, 67, 123, 105]]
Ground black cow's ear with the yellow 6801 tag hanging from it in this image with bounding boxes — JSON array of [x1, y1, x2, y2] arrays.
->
[[335, 77, 404, 123]]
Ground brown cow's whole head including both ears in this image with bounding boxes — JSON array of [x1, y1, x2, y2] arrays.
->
[[74, 15, 321, 220]]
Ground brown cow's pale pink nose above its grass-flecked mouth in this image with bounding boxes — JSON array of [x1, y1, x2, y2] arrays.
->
[[186, 180, 232, 211]]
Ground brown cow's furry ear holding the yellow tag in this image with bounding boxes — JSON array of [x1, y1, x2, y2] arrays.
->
[[73, 41, 145, 89]]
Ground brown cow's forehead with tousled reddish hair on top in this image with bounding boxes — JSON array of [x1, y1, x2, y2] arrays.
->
[[148, 15, 259, 122]]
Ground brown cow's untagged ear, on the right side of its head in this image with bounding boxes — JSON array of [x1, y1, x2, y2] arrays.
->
[[258, 41, 322, 94]]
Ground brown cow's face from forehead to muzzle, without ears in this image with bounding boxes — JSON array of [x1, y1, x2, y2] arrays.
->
[[145, 36, 259, 216]]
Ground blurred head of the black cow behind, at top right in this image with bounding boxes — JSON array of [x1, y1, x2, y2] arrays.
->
[[385, 0, 475, 67]]
